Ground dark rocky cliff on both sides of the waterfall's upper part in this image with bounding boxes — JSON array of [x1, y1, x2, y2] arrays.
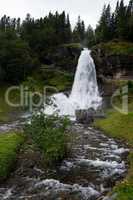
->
[[44, 42, 133, 79]]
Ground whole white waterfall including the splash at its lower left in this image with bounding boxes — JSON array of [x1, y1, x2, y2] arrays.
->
[[45, 48, 102, 118]]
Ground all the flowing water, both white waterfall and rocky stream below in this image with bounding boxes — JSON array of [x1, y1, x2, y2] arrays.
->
[[0, 49, 129, 200]]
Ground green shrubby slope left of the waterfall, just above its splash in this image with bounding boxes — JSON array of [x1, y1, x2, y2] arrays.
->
[[26, 65, 73, 93]]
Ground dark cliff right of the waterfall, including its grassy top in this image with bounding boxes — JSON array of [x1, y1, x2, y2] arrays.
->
[[92, 43, 133, 78]]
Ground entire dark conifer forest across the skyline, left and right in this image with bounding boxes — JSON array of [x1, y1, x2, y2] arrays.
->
[[0, 0, 133, 83]]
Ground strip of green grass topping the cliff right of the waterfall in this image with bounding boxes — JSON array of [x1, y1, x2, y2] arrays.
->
[[94, 41, 133, 56]]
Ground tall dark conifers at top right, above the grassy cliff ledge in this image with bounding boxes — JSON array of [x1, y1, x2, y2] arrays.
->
[[95, 0, 133, 43]]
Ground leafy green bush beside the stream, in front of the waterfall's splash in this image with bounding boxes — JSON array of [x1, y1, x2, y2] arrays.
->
[[24, 113, 70, 164]]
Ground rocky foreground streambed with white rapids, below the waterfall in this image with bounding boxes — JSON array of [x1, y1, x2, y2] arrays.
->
[[0, 119, 129, 200]]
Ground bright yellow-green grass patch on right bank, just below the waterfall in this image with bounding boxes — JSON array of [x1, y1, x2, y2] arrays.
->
[[95, 104, 133, 145]]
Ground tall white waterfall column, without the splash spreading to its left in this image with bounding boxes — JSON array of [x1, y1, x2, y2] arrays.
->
[[70, 49, 101, 109]]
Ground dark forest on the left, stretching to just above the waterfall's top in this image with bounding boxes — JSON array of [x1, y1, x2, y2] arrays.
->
[[0, 11, 88, 83]]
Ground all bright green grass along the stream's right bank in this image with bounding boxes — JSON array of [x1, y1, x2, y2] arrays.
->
[[94, 102, 133, 200]]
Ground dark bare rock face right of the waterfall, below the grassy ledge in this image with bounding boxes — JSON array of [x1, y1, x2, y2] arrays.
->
[[91, 46, 133, 80]]
